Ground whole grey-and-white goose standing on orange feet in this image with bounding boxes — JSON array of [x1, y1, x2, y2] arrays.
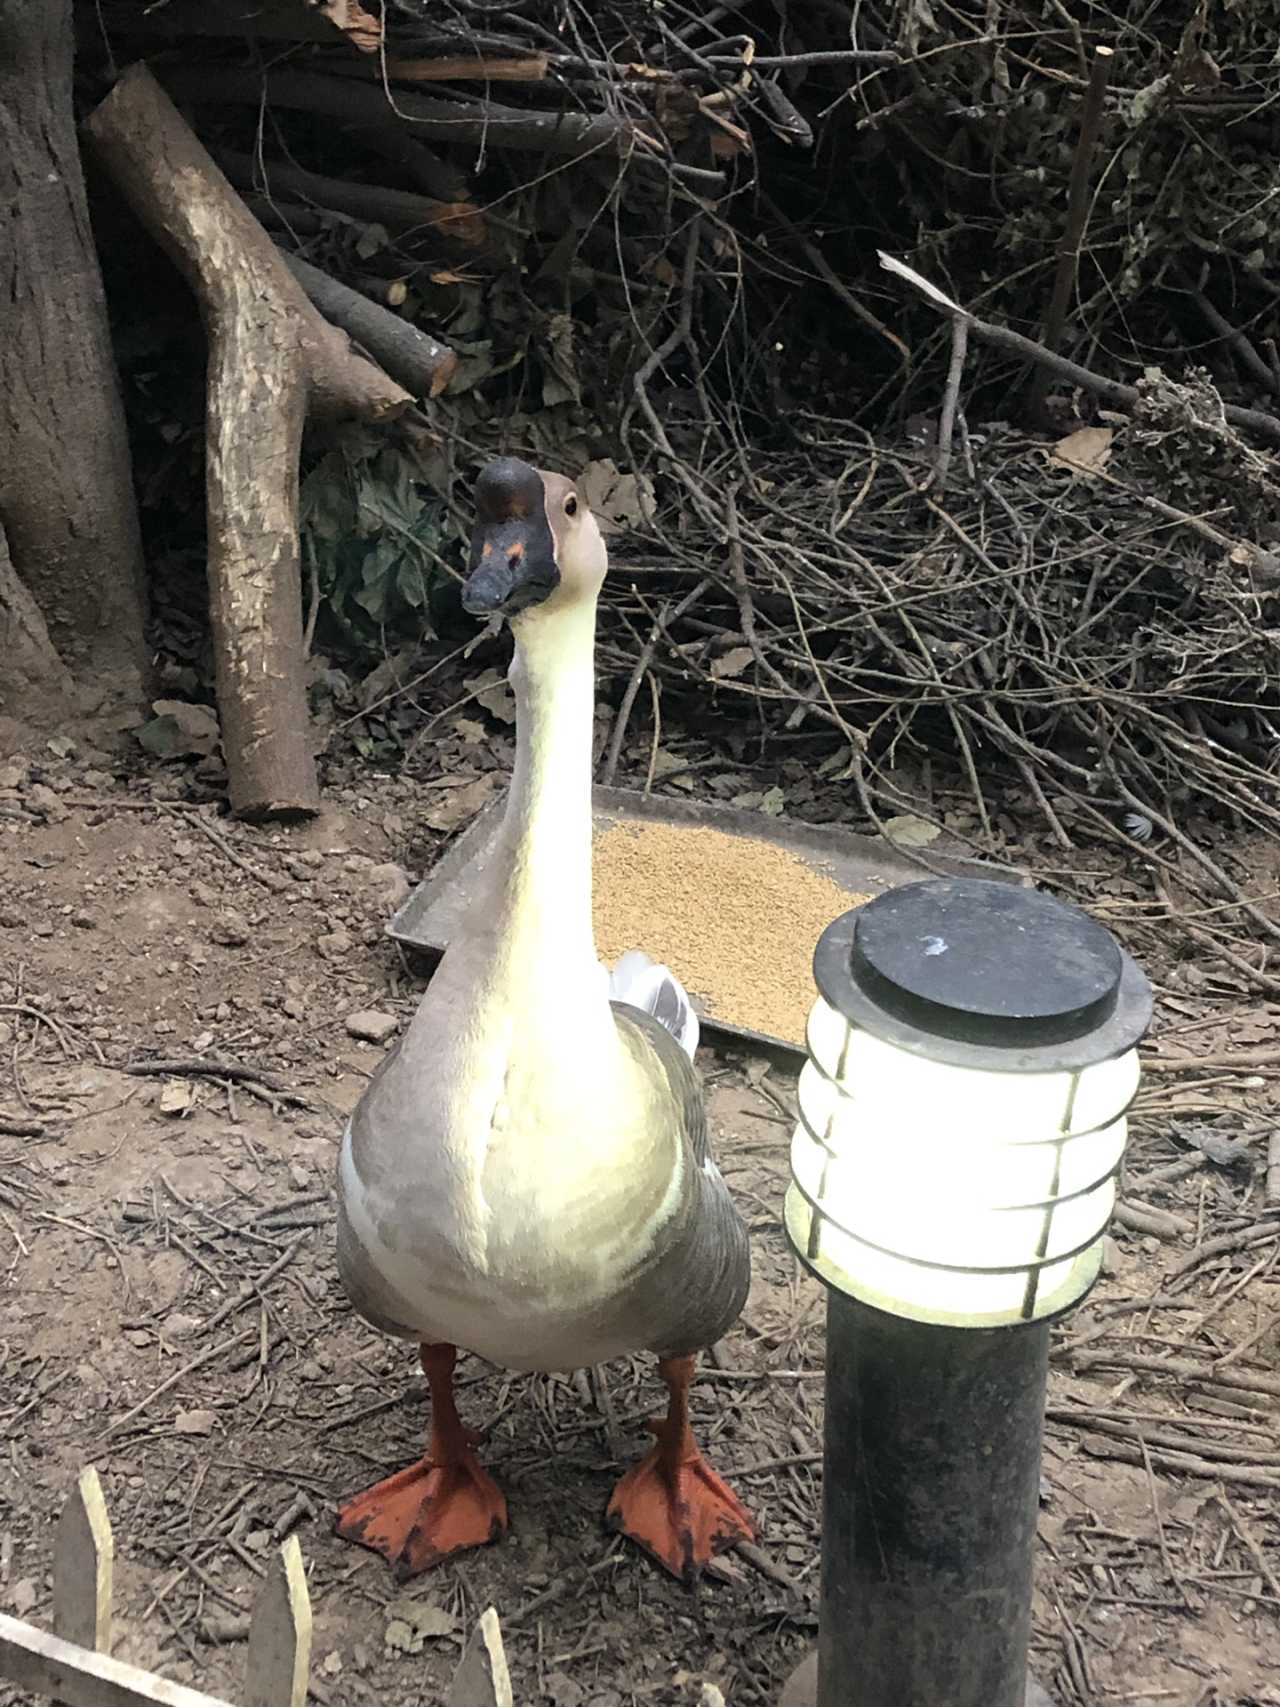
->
[[336, 457, 754, 1581]]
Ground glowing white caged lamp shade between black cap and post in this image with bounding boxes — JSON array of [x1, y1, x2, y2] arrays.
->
[[785, 1000, 1138, 1328]]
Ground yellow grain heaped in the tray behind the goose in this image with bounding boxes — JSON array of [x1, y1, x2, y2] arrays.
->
[[594, 819, 867, 1045]]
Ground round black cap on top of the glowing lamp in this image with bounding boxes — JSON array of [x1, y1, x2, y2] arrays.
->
[[814, 877, 1152, 1072]]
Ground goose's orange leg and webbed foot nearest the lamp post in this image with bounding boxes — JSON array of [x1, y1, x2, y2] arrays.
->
[[608, 1357, 756, 1579]]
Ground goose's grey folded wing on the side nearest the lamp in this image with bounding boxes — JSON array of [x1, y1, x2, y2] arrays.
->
[[613, 1002, 751, 1357]]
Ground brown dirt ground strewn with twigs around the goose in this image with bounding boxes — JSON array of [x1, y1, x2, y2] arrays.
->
[[0, 743, 1280, 1707]]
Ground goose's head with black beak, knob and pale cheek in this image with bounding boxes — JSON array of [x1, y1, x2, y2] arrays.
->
[[463, 456, 608, 618]]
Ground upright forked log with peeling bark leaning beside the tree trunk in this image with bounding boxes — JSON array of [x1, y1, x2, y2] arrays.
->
[[85, 65, 411, 818]]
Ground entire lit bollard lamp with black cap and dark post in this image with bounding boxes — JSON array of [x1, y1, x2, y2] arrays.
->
[[785, 879, 1152, 1707]]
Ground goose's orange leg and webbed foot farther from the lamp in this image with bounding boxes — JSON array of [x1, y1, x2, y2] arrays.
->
[[336, 1345, 507, 1582]]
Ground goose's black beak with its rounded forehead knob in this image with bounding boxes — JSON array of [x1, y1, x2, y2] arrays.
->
[[463, 456, 560, 616]]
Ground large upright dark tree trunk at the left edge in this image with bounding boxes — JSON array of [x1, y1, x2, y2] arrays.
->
[[0, 0, 147, 703]]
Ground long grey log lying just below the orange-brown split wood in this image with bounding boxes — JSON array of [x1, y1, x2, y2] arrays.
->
[[164, 67, 635, 155]]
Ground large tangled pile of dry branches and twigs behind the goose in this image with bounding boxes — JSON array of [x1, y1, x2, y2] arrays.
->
[[80, 0, 1280, 894]]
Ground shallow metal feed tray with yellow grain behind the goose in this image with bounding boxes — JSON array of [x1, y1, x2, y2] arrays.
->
[[387, 789, 1022, 1055]]
